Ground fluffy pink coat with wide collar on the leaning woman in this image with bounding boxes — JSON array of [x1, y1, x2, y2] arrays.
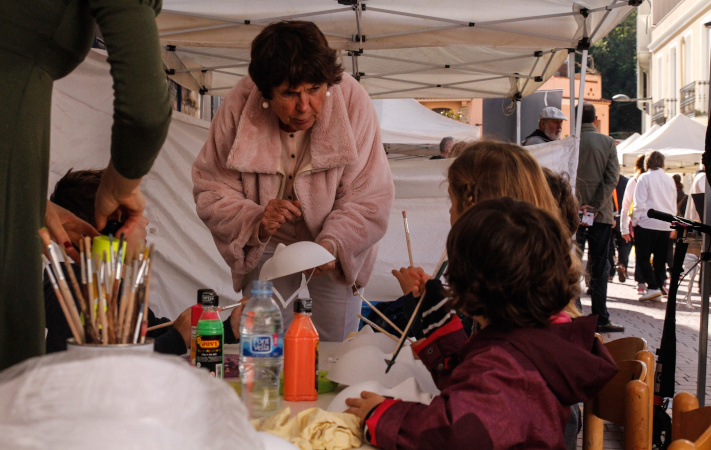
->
[[193, 74, 394, 291]]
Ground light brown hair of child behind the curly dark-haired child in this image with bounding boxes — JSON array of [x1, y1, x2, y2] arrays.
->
[[447, 141, 560, 217]]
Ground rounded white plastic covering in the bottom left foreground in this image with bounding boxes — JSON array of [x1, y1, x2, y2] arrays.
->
[[0, 350, 264, 450]]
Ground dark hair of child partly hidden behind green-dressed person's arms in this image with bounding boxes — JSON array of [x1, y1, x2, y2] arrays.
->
[[49, 169, 104, 226]]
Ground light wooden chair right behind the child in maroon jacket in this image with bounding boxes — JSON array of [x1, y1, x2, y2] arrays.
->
[[583, 360, 652, 450]]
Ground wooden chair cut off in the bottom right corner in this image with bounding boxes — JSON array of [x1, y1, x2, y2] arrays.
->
[[669, 392, 711, 450]]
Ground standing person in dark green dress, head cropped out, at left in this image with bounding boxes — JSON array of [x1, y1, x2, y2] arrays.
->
[[0, 0, 171, 370]]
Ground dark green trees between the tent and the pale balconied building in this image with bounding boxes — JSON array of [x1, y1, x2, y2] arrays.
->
[[590, 10, 642, 135]]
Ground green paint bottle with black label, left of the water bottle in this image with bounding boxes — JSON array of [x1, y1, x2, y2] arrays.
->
[[195, 292, 225, 379]]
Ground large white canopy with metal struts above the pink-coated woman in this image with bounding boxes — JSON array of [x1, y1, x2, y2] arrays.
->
[[157, 0, 641, 98]]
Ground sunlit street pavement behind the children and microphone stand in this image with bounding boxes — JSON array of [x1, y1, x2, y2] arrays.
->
[[578, 254, 711, 449]]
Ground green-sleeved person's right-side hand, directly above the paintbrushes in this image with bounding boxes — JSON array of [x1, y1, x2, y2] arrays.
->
[[94, 161, 146, 241]]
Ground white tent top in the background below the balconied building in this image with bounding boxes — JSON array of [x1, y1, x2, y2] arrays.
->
[[619, 114, 706, 169]]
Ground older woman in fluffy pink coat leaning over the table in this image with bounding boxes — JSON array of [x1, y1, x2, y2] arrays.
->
[[193, 21, 394, 341]]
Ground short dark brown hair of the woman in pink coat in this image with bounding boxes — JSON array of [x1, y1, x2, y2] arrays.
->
[[249, 20, 343, 100]]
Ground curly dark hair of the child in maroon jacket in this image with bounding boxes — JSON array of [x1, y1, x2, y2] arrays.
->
[[445, 197, 580, 328]]
